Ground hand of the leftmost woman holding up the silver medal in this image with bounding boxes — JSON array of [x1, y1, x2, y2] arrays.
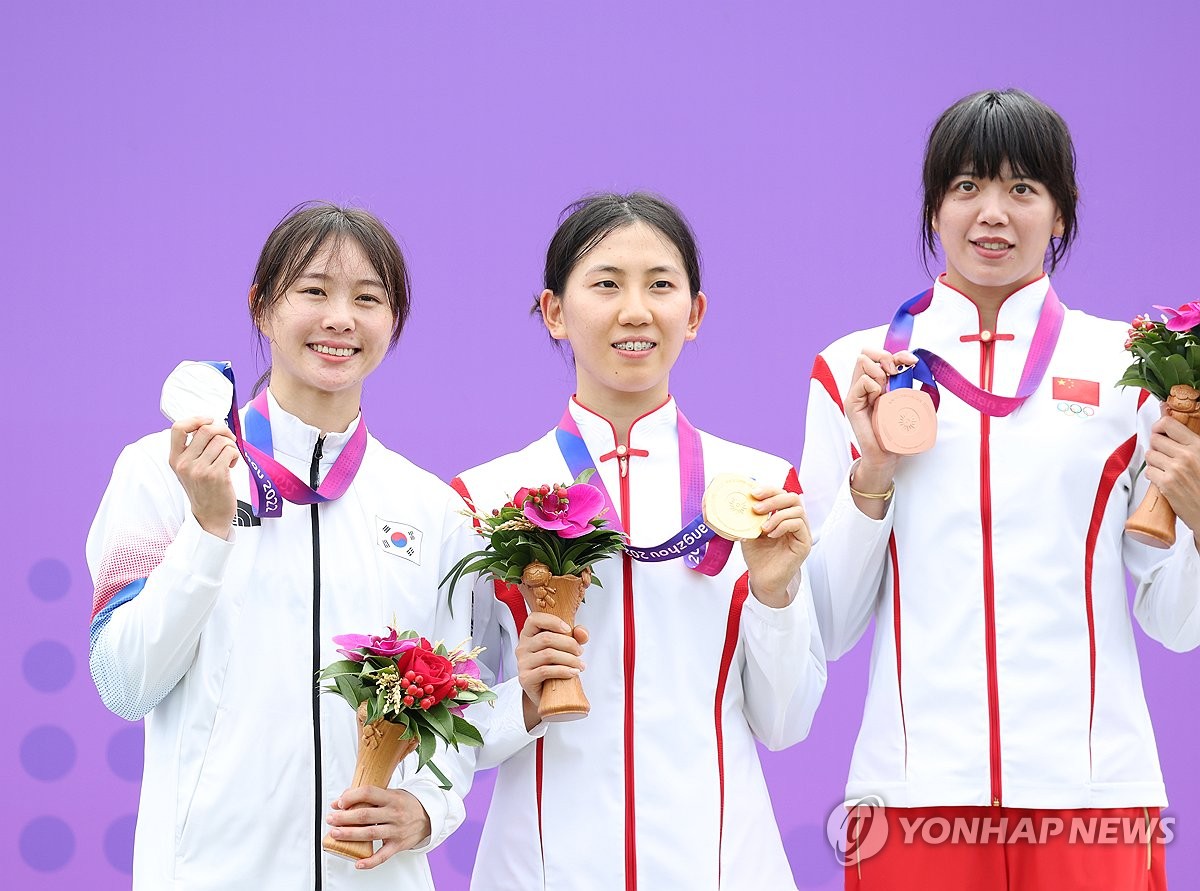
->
[[169, 418, 238, 539]]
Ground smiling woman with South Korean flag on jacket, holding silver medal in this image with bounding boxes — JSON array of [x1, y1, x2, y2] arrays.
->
[[88, 204, 472, 891]]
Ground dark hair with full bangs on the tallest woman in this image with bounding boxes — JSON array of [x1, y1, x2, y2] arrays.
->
[[922, 90, 1079, 271]]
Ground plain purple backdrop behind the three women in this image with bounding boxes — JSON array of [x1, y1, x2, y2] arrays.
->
[[0, 0, 1200, 891]]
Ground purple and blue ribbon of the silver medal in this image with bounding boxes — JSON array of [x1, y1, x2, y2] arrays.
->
[[209, 361, 367, 518]]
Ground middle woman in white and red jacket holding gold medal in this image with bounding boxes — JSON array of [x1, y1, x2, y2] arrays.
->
[[455, 193, 824, 891]]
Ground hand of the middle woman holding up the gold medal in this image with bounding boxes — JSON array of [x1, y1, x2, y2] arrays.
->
[[742, 486, 812, 608]]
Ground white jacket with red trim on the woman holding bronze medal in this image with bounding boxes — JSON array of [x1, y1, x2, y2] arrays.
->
[[800, 277, 1200, 808]]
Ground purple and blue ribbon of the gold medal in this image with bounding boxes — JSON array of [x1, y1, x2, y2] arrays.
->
[[554, 407, 733, 575]]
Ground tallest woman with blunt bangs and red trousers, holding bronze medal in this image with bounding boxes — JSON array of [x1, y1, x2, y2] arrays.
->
[[802, 90, 1200, 891]]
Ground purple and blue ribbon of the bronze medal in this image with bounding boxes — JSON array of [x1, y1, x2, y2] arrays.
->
[[883, 285, 1067, 418]]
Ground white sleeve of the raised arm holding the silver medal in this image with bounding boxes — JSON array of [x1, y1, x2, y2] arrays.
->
[[86, 437, 233, 720]]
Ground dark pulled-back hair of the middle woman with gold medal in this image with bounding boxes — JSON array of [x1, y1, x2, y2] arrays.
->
[[533, 192, 700, 313]]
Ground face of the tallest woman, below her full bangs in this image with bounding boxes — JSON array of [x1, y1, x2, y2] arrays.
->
[[932, 163, 1063, 304]]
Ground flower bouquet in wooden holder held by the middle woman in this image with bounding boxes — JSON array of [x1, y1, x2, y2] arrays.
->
[[442, 470, 625, 720]]
